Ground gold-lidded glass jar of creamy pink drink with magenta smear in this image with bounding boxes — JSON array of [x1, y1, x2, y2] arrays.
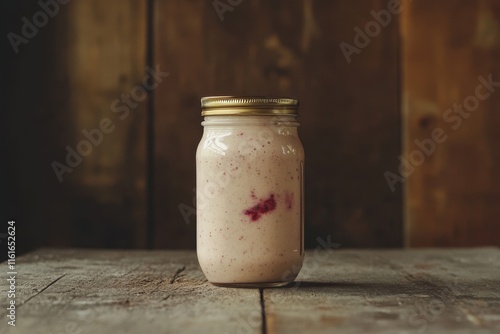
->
[[196, 96, 304, 287]]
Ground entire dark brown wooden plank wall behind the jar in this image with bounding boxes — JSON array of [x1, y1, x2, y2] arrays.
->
[[2, 0, 500, 256]]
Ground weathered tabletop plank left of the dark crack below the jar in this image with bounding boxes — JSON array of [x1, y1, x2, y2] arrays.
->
[[0, 250, 262, 334]]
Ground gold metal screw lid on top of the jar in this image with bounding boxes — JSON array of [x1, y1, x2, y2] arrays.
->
[[201, 96, 299, 116]]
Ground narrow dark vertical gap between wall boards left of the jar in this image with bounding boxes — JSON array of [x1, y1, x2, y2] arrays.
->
[[146, 0, 155, 249]]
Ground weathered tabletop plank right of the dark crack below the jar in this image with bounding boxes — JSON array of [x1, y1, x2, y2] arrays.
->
[[264, 248, 500, 334]]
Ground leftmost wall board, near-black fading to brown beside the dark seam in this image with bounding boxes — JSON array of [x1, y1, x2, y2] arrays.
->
[[3, 0, 147, 250]]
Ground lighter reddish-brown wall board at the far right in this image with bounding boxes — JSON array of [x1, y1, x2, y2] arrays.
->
[[402, 0, 500, 246]]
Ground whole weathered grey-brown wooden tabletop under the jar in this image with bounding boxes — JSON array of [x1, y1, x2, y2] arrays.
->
[[0, 248, 500, 334]]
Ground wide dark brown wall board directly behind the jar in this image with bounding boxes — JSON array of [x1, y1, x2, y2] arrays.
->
[[155, 0, 402, 248]]
